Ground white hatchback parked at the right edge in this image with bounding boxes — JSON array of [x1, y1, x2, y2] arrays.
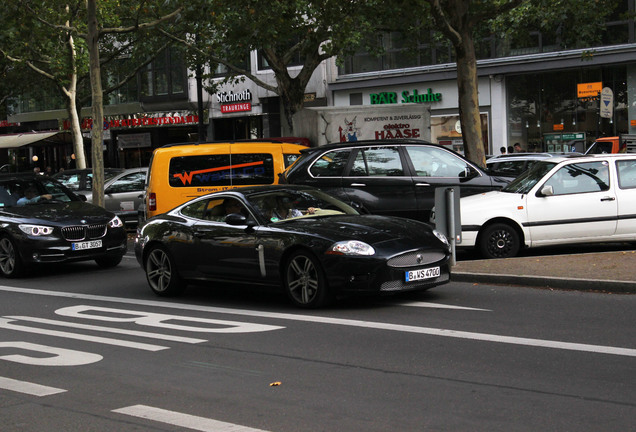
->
[[444, 154, 636, 258]]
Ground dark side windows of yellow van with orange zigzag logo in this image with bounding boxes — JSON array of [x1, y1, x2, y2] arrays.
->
[[168, 153, 274, 188]]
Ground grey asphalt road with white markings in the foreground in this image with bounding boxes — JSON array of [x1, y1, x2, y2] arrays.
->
[[0, 251, 636, 432]]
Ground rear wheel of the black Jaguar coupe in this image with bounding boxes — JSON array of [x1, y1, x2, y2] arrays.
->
[[144, 247, 185, 297]]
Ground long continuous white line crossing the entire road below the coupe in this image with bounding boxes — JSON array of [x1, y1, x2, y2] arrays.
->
[[0, 286, 636, 357]]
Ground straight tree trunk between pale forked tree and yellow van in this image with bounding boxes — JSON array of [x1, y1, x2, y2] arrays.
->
[[86, 0, 104, 207]]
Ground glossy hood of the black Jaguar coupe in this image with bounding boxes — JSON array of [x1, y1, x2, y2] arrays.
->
[[274, 215, 442, 248]]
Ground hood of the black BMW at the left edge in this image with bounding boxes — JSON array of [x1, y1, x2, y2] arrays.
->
[[0, 201, 115, 225]]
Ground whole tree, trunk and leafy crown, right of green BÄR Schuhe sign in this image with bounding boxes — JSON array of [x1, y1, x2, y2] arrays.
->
[[394, 0, 617, 167]]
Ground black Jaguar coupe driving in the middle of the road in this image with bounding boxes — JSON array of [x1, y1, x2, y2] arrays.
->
[[135, 185, 450, 308]]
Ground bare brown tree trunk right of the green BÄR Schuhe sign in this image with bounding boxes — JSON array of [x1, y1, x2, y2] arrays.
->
[[455, 30, 486, 167]]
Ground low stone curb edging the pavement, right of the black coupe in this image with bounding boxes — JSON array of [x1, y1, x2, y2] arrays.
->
[[451, 271, 636, 294]]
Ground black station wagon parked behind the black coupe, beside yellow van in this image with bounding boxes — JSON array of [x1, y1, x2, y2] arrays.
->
[[281, 140, 512, 222]]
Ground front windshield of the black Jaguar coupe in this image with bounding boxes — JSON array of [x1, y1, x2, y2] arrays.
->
[[247, 189, 358, 222]]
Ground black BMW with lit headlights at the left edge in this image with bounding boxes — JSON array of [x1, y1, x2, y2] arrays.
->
[[0, 174, 127, 278]]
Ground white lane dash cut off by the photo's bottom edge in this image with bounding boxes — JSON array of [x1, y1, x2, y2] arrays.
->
[[113, 405, 266, 432]]
